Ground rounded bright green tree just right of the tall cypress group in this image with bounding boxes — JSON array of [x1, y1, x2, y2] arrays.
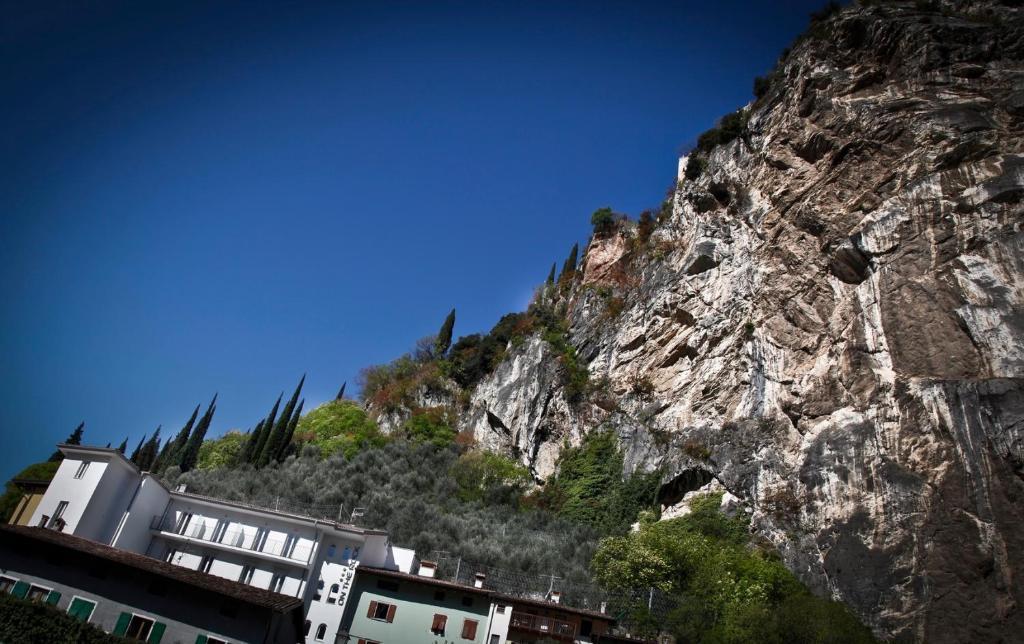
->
[[295, 400, 387, 459]]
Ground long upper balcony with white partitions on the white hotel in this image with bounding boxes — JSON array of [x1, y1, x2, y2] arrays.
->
[[150, 516, 313, 567]]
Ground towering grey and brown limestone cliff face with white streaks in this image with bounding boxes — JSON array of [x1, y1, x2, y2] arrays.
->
[[461, 3, 1024, 642]]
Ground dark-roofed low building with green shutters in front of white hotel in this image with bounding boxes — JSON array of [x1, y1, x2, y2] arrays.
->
[[0, 525, 303, 644]]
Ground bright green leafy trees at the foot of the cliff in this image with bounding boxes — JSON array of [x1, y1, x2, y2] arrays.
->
[[593, 495, 874, 644]]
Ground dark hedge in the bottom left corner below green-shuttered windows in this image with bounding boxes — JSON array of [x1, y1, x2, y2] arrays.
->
[[0, 593, 127, 644]]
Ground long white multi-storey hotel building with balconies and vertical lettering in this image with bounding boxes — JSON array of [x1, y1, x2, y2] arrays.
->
[[30, 445, 417, 642]]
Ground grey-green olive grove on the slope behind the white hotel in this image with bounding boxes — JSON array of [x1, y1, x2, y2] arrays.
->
[[168, 439, 599, 582]]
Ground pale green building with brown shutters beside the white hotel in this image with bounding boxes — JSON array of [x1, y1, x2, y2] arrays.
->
[[339, 566, 492, 644]]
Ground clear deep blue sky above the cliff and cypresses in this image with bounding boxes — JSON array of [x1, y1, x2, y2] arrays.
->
[[0, 0, 823, 480]]
